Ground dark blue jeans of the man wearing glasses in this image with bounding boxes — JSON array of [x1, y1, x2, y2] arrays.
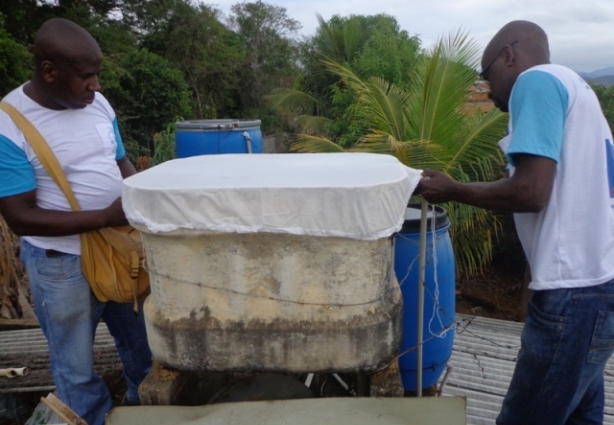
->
[[497, 281, 614, 425]]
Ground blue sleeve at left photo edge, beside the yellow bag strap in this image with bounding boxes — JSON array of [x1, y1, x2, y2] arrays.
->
[[0, 134, 36, 198]]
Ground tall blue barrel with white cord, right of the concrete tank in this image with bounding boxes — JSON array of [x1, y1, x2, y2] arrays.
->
[[394, 204, 456, 391]]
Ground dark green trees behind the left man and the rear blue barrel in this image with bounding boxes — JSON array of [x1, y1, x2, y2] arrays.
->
[[0, 0, 300, 160]]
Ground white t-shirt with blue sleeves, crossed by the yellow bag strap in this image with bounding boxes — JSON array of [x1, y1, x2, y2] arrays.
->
[[0, 86, 125, 255]]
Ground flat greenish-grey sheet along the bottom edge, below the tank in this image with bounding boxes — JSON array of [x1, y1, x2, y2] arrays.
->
[[105, 397, 467, 425]]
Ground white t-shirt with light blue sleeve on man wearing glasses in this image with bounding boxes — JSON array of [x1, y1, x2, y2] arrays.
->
[[501, 65, 614, 290]]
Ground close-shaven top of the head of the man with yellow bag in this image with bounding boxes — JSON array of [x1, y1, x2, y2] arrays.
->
[[34, 18, 102, 70]]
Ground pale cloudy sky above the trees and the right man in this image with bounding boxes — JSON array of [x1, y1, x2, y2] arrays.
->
[[206, 0, 614, 72]]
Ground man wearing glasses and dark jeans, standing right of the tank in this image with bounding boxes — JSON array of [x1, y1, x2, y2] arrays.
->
[[417, 21, 614, 425]]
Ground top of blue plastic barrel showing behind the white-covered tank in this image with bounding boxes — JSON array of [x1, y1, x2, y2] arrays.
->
[[175, 120, 262, 158]]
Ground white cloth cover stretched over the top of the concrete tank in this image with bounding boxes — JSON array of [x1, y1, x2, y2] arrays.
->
[[122, 153, 421, 240]]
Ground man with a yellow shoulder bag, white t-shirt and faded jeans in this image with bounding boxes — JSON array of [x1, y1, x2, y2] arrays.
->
[[0, 19, 151, 425]]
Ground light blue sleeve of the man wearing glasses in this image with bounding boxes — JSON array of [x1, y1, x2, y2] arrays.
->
[[507, 70, 569, 165]]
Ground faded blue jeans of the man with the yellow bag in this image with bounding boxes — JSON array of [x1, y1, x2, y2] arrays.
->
[[21, 239, 152, 425]]
